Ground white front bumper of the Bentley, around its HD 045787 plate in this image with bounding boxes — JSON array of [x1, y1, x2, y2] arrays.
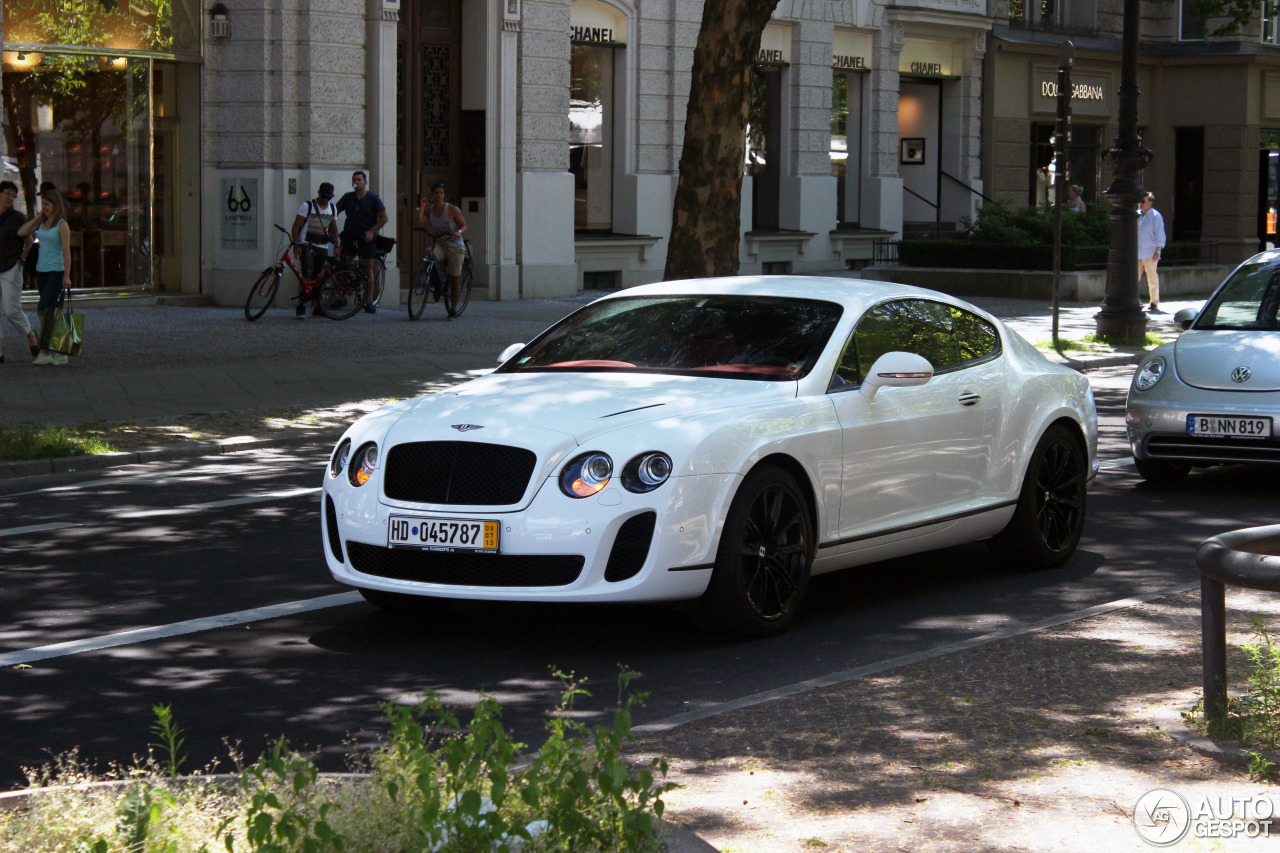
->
[[321, 474, 737, 602]]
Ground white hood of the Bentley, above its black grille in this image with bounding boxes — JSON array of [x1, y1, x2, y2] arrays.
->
[[387, 373, 796, 451]]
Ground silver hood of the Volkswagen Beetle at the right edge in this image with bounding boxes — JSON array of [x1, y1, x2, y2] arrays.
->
[[1174, 329, 1280, 391]]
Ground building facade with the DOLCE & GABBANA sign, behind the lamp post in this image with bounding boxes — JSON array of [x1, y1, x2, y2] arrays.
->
[[983, 0, 1280, 263]]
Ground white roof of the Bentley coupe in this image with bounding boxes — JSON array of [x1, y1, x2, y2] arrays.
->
[[604, 275, 986, 315]]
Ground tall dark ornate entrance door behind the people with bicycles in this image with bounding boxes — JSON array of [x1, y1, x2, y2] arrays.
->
[[396, 0, 462, 275]]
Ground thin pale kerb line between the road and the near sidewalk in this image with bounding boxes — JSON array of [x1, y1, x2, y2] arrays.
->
[[631, 580, 1199, 734]]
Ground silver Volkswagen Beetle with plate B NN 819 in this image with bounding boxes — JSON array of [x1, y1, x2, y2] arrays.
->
[[1125, 251, 1280, 484]]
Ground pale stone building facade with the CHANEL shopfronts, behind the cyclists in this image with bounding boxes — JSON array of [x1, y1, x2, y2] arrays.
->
[[0, 0, 993, 305]]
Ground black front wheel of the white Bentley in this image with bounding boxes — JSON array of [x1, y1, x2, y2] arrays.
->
[[694, 465, 814, 637]]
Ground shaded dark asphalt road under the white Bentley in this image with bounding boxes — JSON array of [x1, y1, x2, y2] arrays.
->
[[0, 369, 1276, 789]]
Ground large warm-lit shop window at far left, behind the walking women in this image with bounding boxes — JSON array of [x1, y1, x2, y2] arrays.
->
[[0, 51, 152, 288]]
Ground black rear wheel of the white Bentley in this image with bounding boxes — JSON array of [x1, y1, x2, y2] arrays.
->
[[992, 424, 1088, 570]]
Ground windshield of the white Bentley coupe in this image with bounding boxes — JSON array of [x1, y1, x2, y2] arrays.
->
[[498, 296, 842, 380]]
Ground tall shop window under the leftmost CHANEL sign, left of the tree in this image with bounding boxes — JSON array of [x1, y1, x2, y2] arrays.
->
[[568, 44, 621, 232]]
